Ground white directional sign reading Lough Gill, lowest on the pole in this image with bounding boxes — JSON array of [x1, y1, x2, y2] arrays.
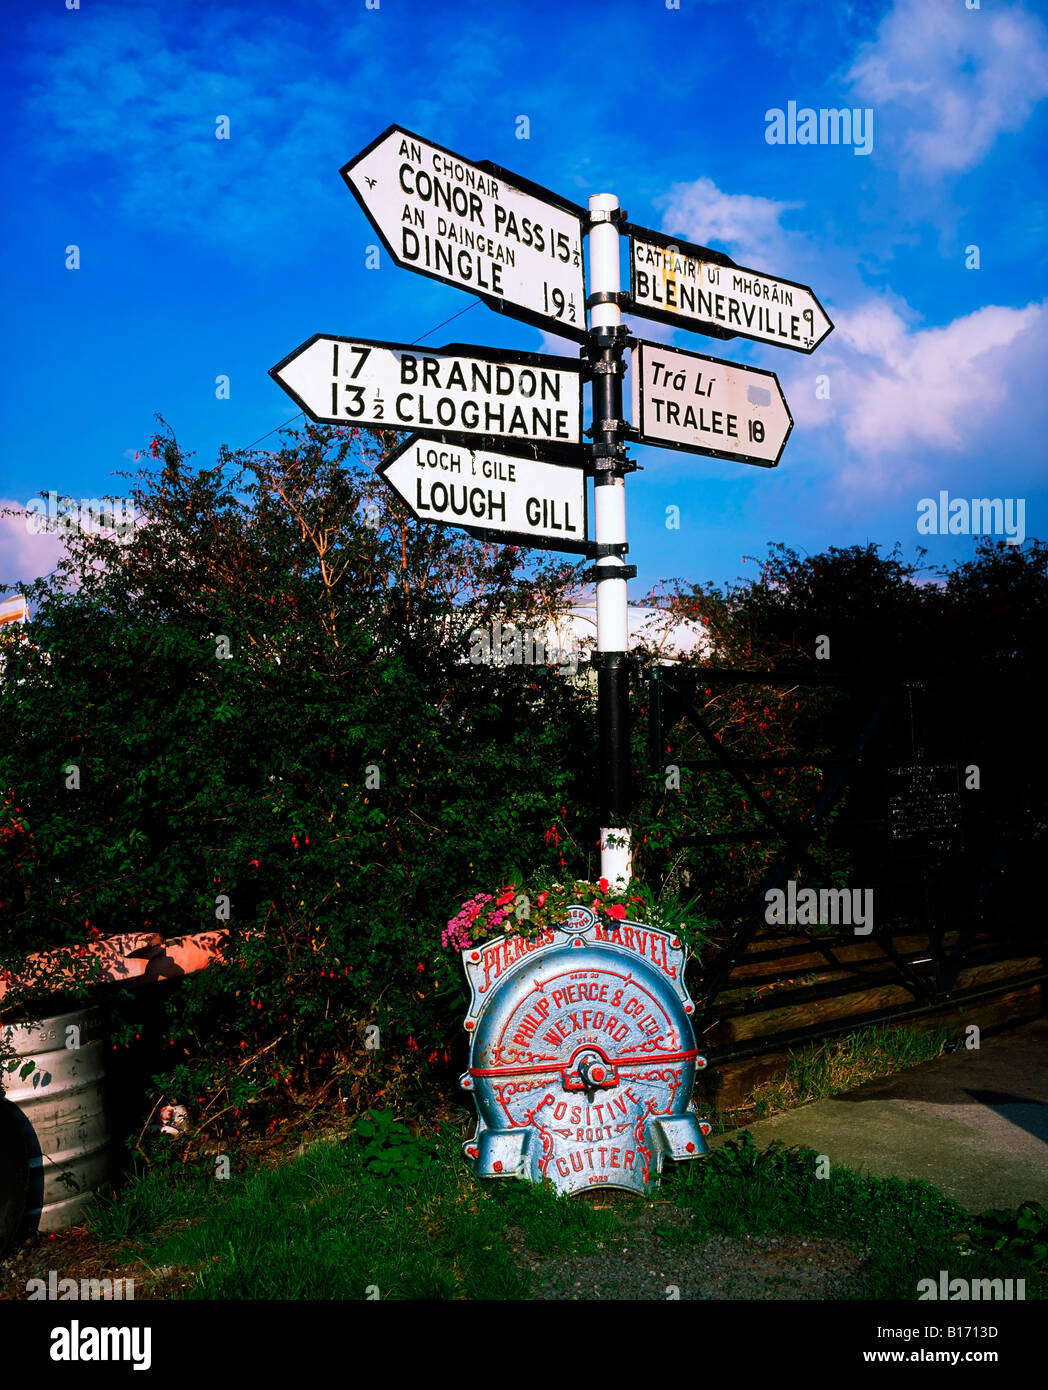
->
[[378, 435, 589, 555]]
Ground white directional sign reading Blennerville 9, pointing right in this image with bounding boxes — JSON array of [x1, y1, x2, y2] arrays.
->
[[628, 227, 833, 352]]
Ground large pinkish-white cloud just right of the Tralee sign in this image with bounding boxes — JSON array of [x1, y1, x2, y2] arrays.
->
[[780, 290, 1048, 492]]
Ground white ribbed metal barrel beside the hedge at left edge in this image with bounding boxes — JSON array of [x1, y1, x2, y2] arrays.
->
[[0, 1011, 110, 1234]]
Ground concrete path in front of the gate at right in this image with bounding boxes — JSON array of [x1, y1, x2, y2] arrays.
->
[[710, 1019, 1048, 1212]]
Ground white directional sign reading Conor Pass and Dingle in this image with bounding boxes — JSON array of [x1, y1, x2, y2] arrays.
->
[[341, 125, 588, 342]]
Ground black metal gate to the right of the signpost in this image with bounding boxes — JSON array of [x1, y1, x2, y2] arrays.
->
[[646, 666, 1048, 1061]]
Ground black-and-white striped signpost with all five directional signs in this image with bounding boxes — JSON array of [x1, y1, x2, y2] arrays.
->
[[270, 125, 833, 884]]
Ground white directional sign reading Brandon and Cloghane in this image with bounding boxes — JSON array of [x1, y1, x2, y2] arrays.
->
[[270, 334, 582, 450]]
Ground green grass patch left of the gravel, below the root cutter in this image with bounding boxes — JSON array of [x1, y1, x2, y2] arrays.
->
[[89, 1127, 617, 1300]]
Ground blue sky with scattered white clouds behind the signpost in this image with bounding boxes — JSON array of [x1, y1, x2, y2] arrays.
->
[[0, 0, 1048, 598]]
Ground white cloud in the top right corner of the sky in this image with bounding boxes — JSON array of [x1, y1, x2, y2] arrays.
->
[[848, 0, 1048, 174]]
